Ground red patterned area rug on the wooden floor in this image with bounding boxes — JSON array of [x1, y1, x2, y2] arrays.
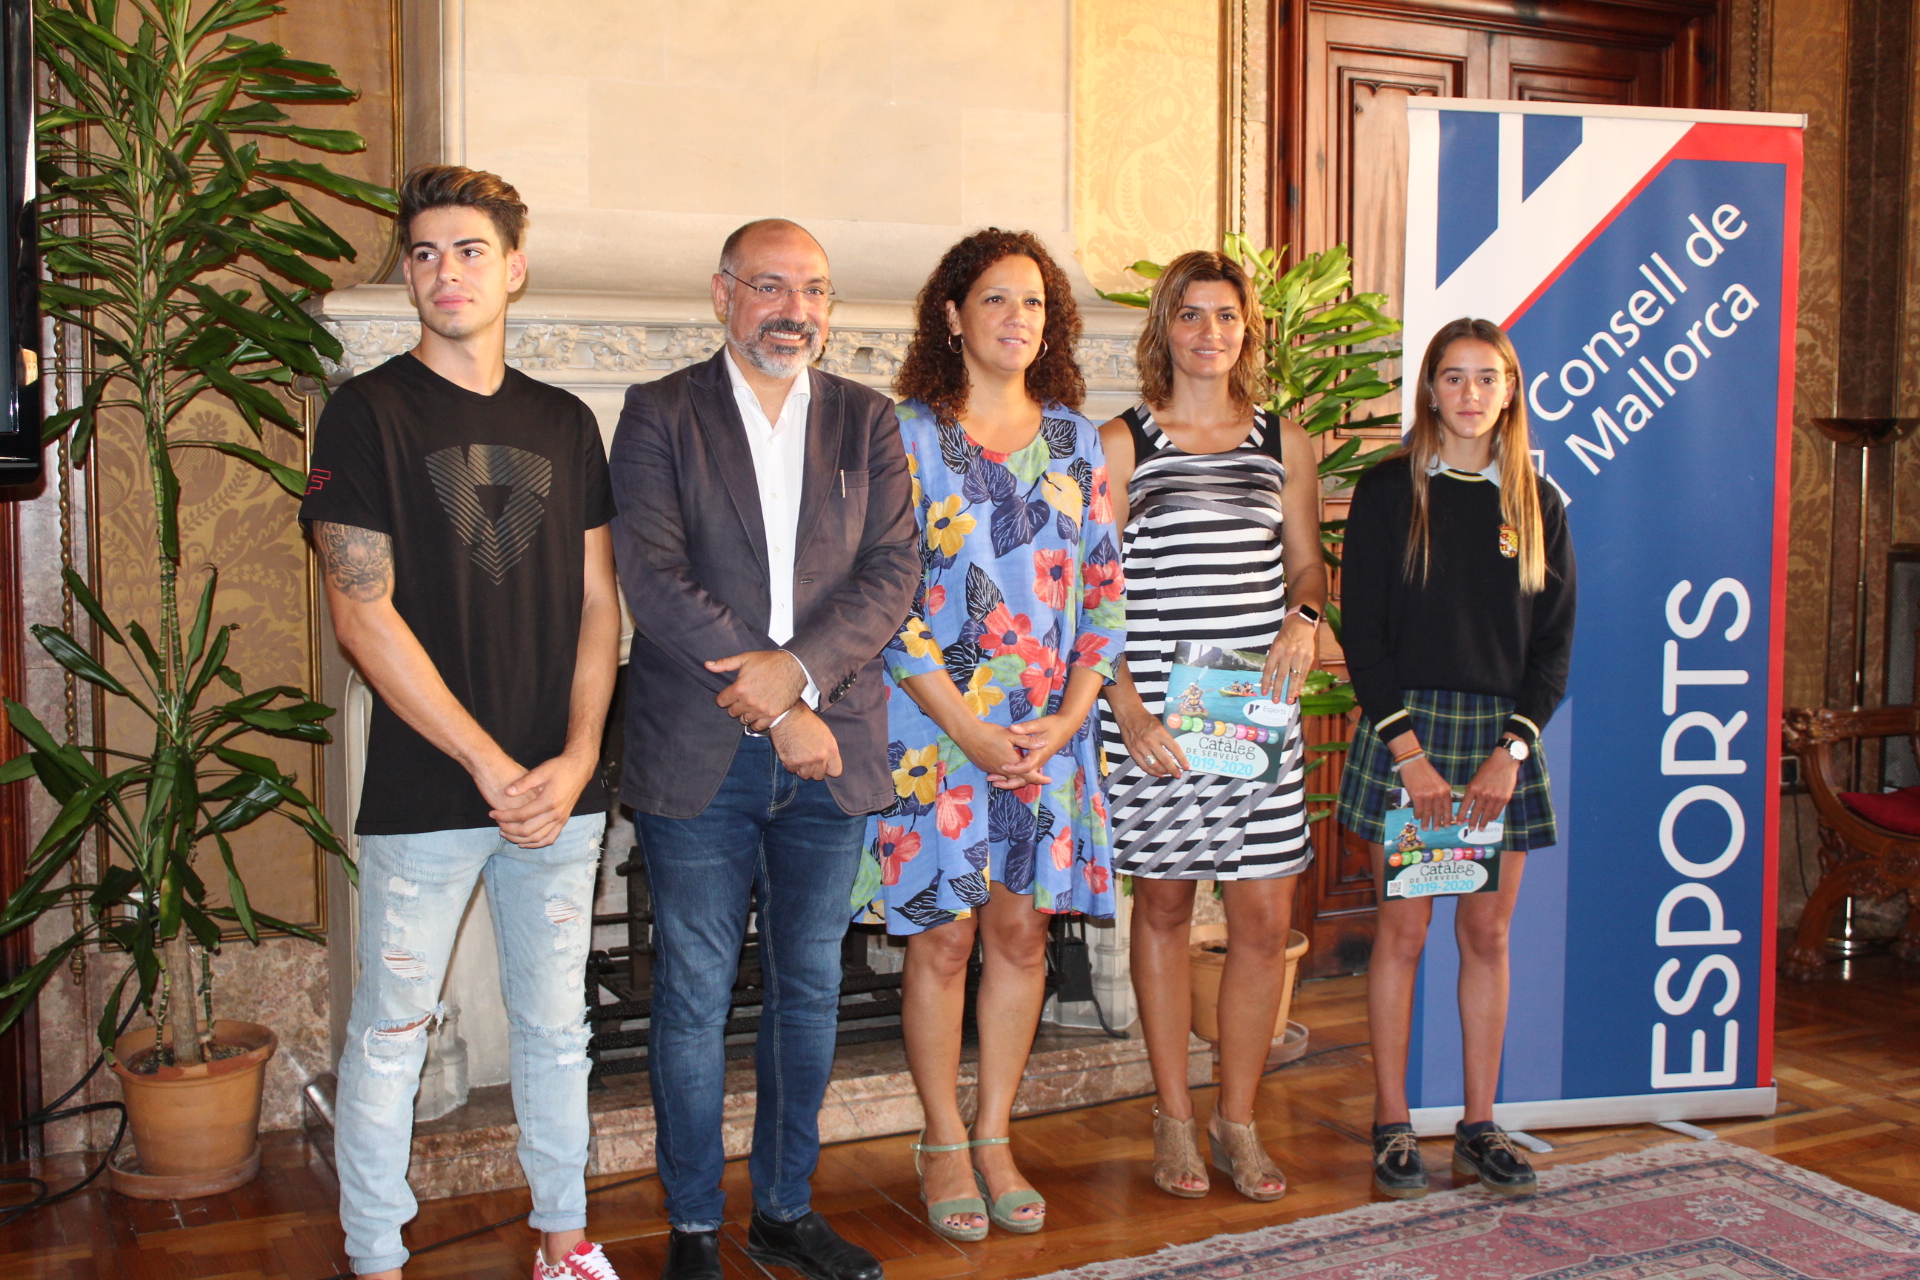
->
[[1044, 1142, 1920, 1280]]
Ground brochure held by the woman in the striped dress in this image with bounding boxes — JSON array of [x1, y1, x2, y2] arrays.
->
[[1165, 641, 1300, 783]]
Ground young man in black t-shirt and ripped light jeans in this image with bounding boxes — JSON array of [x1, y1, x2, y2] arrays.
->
[[300, 165, 620, 1280]]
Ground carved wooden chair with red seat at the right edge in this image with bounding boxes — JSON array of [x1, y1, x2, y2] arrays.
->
[[1780, 706, 1920, 979]]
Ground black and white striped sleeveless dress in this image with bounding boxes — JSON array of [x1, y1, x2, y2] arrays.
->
[[1100, 405, 1313, 881]]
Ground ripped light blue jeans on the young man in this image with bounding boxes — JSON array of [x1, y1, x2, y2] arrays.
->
[[334, 814, 607, 1274]]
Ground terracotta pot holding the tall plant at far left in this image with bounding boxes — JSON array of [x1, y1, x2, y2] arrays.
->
[[113, 1021, 280, 1196]]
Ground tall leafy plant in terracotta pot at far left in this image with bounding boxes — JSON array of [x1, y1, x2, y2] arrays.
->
[[0, 0, 394, 1196]]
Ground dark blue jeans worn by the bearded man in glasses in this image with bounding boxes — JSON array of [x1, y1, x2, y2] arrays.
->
[[634, 737, 866, 1230]]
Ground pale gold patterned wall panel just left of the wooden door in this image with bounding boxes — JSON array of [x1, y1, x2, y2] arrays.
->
[[1073, 0, 1221, 290]]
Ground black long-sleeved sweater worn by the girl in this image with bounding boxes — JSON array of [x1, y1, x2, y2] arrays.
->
[[1340, 457, 1574, 741]]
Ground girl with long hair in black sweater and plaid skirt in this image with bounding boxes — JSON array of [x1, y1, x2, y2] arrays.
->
[[1340, 319, 1574, 1197]]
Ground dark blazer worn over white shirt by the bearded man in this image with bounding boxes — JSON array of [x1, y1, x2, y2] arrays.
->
[[611, 351, 920, 818]]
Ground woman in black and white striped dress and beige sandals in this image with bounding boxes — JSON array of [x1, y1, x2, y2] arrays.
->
[[1100, 253, 1327, 1199]]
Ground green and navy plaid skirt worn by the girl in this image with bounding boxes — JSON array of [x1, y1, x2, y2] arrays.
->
[[1340, 689, 1559, 850]]
